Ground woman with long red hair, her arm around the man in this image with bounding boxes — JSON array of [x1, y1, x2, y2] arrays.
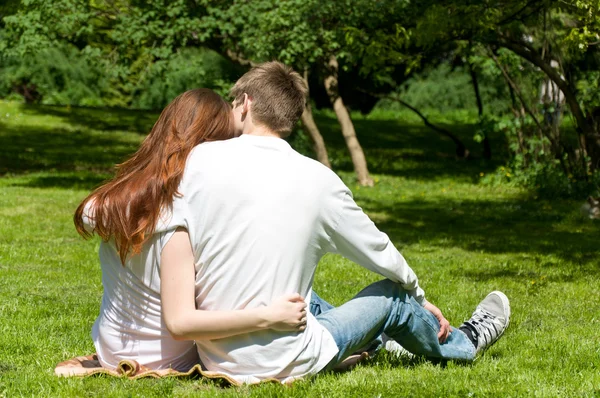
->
[[74, 89, 306, 371]]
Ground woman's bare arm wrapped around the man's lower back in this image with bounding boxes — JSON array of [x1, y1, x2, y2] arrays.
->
[[160, 228, 306, 340]]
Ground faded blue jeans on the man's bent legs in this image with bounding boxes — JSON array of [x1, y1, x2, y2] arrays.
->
[[310, 279, 475, 369]]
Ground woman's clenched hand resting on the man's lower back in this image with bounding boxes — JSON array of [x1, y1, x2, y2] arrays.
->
[[263, 293, 306, 332]]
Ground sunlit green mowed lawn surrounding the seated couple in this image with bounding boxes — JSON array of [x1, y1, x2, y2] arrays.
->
[[0, 102, 600, 397]]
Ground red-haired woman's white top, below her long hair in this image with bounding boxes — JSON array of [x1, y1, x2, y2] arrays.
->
[[92, 232, 199, 371]]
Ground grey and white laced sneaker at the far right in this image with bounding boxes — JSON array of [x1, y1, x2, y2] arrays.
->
[[459, 291, 510, 353]]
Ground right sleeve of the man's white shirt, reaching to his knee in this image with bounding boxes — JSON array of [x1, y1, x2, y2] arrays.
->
[[330, 190, 427, 305]]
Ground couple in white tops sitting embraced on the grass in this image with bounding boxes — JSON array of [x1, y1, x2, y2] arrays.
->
[[75, 62, 510, 383]]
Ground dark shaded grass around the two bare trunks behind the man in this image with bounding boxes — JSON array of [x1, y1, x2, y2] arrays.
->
[[317, 115, 507, 180]]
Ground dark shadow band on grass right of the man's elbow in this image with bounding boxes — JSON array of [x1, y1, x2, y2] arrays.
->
[[359, 198, 600, 270]]
